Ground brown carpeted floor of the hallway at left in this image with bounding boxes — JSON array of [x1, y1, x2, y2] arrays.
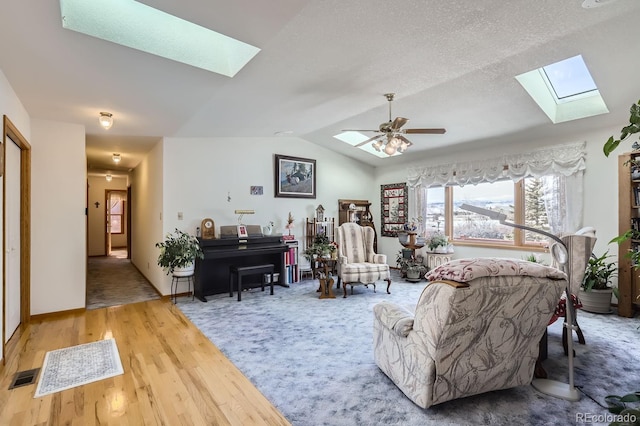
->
[[87, 249, 160, 310]]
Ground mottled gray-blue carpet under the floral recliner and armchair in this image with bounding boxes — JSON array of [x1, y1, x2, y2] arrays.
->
[[178, 274, 640, 426]]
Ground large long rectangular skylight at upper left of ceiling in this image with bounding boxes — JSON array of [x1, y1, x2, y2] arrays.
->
[[60, 0, 260, 77]]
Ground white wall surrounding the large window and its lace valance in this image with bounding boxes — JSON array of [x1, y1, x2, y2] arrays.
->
[[374, 128, 630, 266]]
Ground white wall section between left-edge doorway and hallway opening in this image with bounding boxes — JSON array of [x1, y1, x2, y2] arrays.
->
[[30, 120, 87, 315]]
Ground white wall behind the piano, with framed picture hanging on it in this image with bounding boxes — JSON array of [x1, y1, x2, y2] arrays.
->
[[152, 137, 376, 294]]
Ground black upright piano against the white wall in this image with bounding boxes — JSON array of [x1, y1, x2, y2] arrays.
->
[[194, 235, 288, 302]]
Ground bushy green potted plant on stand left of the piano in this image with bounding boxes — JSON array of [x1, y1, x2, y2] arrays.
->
[[156, 228, 204, 276]]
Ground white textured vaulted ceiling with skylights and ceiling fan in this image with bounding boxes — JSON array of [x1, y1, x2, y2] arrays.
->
[[0, 0, 640, 171]]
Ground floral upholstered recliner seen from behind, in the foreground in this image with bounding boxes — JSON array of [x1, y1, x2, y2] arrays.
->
[[373, 258, 567, 408]]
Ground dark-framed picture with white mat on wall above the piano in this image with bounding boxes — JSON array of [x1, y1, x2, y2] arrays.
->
[[274, 154, 317, 198]]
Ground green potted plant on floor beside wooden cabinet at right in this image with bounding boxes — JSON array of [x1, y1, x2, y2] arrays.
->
[[578, 251, 618, 314]]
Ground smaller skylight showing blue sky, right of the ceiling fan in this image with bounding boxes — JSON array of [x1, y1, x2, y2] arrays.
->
[[516, 55, 609, 123]]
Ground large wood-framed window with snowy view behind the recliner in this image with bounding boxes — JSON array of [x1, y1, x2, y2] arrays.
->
[[424, 178, 553, 249]]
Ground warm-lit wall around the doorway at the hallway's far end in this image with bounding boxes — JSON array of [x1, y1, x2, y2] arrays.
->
[[87, 176, 128, 256]]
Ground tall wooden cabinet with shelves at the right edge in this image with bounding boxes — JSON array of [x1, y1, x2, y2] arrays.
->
[[618, 152, 640, 317]]
